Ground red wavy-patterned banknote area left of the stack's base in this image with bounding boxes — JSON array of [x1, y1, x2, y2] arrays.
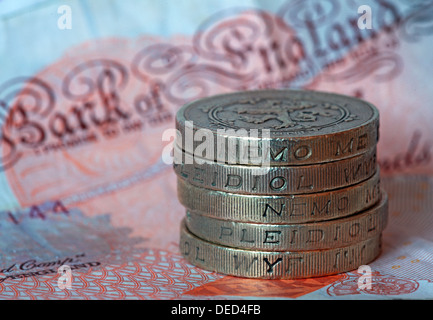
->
[[0, 249, 222, 300]]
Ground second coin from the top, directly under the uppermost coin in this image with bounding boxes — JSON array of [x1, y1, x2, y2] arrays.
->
[[173, 147, 377, 195]]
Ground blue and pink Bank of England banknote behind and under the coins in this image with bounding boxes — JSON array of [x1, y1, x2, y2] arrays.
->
[[0, 0, 433, 300]]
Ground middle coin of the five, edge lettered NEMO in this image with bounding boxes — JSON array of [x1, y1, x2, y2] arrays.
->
[[177, 168, 381, 224]]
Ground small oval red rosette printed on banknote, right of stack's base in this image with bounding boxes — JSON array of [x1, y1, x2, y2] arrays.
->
[[326, 272, 419, 296]]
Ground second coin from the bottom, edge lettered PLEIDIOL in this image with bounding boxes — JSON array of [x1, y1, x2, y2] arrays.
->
[[185, 191, 388, 251]]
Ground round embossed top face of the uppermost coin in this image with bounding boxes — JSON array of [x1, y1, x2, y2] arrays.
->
[[180, 90, 378, 137]]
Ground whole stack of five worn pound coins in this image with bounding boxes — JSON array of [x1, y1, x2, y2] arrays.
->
[[174, 90, 388, 279]]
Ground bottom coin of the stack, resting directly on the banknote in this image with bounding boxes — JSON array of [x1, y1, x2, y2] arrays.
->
[[180, 221, 381, 279]]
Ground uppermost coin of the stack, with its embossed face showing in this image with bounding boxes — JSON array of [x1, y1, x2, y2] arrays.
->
[[175, 90, 379, 166]]
